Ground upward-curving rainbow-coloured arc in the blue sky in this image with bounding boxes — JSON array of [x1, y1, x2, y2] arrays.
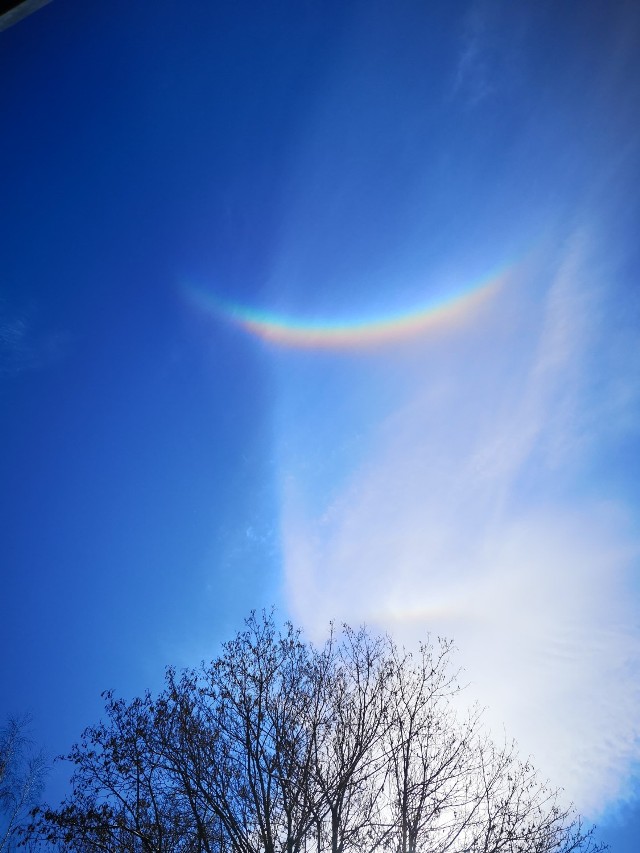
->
[[190, 268, 507, 349]]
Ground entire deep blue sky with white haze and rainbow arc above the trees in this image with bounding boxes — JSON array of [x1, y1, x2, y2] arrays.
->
[[0, 0, 640, 853]]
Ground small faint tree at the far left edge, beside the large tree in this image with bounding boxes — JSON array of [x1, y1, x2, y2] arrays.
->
[[0, 716, 47, 853]]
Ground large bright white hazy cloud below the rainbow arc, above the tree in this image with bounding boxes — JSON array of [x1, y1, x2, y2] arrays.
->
[[282, 231, 640, 814]]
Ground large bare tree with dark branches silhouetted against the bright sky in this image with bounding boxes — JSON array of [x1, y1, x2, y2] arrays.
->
[[26, 614, 603, 853]]
